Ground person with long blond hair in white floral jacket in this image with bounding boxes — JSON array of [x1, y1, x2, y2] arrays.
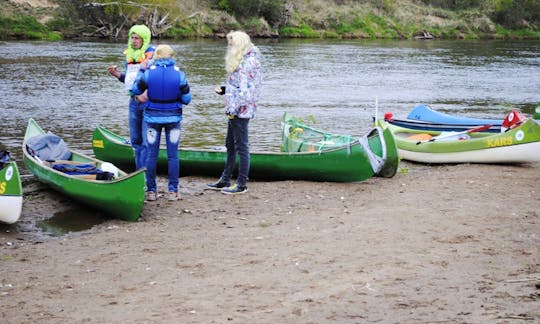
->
[[207, 31, 262, 194]]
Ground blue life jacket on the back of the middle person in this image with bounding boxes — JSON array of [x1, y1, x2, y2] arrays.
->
[[147, 62, 184, 113]]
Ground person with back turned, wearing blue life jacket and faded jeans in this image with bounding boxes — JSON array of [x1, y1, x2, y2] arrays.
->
[[131, 45, 191, 201]]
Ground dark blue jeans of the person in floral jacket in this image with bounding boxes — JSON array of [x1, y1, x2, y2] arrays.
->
[[221, 118, 249, 186]]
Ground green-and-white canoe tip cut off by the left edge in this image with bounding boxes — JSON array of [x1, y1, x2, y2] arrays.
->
[[0, 161, 23, 224]]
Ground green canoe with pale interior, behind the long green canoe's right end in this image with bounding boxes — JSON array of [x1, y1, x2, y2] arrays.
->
[[281, 113, 399, 178]]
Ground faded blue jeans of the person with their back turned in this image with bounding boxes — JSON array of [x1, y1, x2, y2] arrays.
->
[[145, 122, 181, 192]]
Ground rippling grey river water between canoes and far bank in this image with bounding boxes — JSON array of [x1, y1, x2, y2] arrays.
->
[[0, 40, 540, 165]]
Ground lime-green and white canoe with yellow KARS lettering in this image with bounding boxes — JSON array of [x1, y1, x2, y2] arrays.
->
[[379, 119, 540, 163]]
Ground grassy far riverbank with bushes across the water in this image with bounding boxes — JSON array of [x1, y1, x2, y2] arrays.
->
[[0, 0, 540, 39]]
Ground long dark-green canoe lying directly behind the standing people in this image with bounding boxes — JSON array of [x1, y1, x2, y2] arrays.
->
[[92, 120, 397, 182]]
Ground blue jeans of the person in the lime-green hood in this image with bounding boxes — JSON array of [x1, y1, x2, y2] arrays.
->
[[128, 98, 146, 170]]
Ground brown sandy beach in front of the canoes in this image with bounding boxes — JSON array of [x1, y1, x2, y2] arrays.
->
[[0, 162, 540, 323]]
